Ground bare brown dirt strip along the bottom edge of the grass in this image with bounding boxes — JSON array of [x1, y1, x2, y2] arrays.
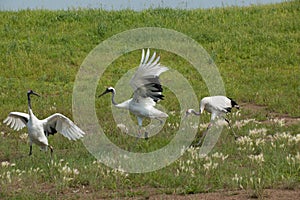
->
[[56, 188, 300, 200]]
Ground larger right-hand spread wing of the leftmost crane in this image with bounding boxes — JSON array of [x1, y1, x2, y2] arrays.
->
[[43, 113, 85, 140]]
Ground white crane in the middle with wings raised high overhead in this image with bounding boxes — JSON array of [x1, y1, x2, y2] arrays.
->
[[99, 49, 168, 138]]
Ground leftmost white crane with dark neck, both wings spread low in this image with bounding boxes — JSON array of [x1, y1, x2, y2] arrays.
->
[[3, 90, 85, 157]]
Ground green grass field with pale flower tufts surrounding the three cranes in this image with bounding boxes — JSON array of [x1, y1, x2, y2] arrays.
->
[[0, 1, 300, 199]]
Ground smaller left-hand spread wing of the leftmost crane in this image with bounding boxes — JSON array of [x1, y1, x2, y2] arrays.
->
[[3, 112, 29, 131]]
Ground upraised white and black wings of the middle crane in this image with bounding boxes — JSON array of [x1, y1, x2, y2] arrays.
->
[[130, 49, 168, 104]]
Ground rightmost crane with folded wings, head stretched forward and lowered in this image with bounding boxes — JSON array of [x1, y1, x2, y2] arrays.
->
[[186, 96, 239, 144]]
